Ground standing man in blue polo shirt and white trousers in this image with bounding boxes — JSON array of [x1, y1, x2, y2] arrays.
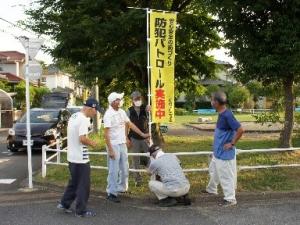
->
[[204, 92, 244, 206]]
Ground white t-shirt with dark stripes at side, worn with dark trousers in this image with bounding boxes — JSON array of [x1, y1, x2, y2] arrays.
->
[[67, 112, 90, 163]]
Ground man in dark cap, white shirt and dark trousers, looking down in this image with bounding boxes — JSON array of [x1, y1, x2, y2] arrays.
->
[[57, 98, 100, 217]]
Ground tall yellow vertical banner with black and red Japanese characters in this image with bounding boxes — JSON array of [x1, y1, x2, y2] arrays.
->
[[149, 11, 176, 123]]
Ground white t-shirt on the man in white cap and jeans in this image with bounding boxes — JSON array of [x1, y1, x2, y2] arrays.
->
[[103, 106, 130, 145]]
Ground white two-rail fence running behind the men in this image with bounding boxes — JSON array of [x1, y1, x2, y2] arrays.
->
[[42, 138, 300, 177]]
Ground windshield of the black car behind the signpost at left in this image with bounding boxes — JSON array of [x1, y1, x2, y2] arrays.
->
[[19, 111, 59, 123]]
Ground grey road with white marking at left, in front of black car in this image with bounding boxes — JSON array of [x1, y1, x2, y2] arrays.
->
[[0, 140, 42, 192]]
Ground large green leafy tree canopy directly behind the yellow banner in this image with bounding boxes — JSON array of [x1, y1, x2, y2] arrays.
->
[[26, 0, 220, 96]]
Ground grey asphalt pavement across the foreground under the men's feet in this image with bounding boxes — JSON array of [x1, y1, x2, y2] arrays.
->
[[0, 194, 300, 225]]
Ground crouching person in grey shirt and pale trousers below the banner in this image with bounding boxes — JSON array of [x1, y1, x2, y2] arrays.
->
[[149, 145, 191, 207]]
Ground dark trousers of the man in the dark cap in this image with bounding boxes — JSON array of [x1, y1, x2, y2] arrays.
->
[[61, 162, 91, 214]]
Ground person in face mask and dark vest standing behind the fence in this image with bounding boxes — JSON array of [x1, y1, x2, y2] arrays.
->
[[127, 91, 149, 187]]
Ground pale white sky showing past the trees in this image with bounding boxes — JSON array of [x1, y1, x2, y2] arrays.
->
[[0, 0, 236, 65]]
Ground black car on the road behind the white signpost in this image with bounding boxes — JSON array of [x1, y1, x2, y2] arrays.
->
[[7, 108, 70, 152]]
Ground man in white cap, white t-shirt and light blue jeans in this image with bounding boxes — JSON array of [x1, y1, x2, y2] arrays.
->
[[103, 92, 149, 203]]
